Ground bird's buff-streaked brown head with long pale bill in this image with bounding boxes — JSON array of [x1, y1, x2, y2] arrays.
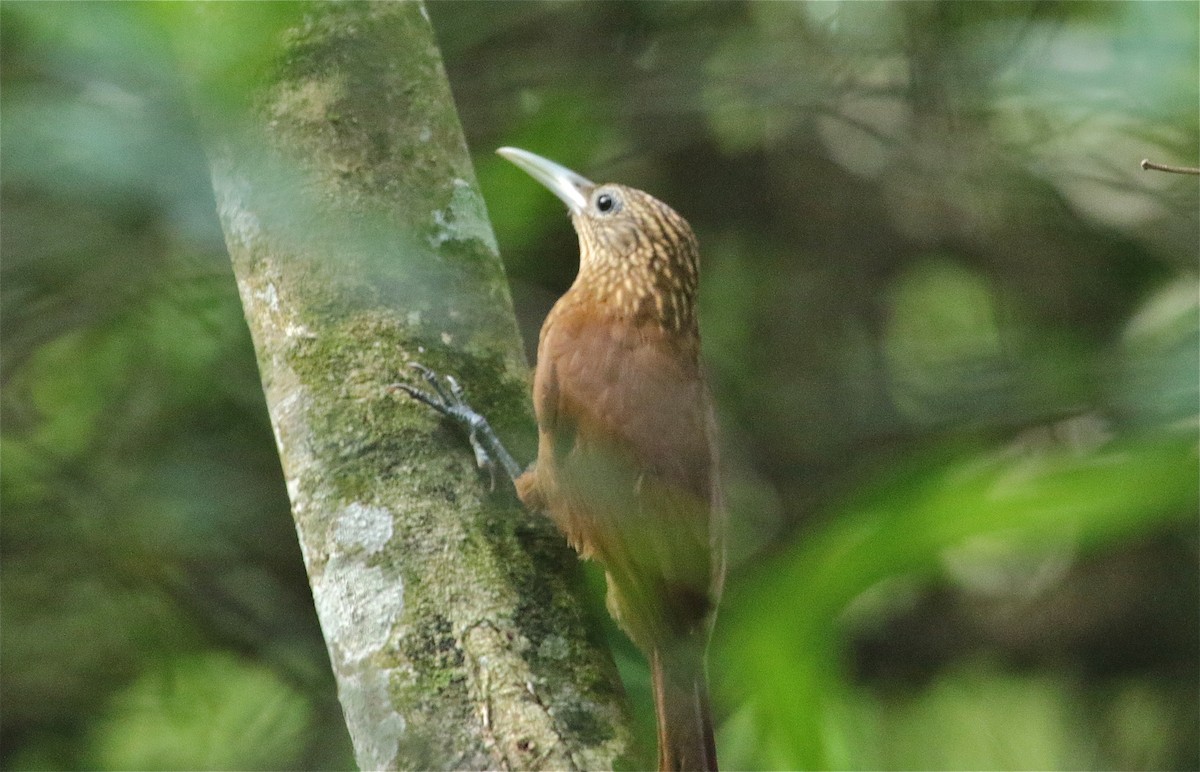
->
[[497, 148, 700, 331]]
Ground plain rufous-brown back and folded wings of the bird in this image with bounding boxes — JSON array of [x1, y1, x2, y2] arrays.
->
[[535, 304, 720, 640]]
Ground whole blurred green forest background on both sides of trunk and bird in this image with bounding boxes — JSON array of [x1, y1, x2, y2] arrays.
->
[[0, 1, 1200, 770]]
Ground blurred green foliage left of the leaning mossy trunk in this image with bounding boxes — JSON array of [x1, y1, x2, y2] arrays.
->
[[0, 2, 353, 770]]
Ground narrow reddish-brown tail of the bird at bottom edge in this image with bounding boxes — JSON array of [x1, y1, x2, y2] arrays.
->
[[650, 650, 716, 772]]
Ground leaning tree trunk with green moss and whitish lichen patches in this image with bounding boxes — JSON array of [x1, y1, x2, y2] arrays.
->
[[201, 2, 630, 770]]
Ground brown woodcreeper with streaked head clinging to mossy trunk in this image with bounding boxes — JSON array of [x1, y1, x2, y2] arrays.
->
[[397, 148, 726, 771]]
